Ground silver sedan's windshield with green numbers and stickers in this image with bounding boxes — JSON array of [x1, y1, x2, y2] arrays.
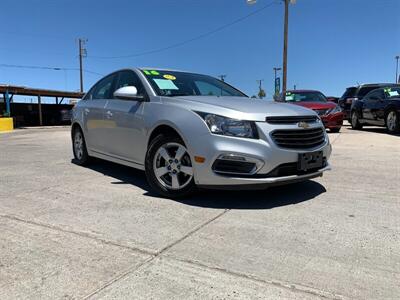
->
[[142, 69, 247, 97]]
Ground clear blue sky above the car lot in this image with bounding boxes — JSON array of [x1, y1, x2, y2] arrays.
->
[[0, 0, 400, 98]]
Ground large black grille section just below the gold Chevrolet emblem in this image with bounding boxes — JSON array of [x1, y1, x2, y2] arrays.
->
[[271, 128, 325, 149]]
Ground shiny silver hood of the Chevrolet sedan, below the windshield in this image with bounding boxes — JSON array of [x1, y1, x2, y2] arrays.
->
[[162, 96, 315, 121]]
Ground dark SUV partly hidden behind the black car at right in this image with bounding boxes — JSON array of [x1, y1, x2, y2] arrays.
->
[[339, 83, 399, 122]]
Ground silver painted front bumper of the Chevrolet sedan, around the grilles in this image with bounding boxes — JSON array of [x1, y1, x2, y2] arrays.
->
[[188, 122, 332, 189]]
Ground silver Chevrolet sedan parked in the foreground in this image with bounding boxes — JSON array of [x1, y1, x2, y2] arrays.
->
[[71, 68, 331, 197]]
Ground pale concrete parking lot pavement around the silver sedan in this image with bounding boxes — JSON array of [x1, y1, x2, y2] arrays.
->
[[0, 127, 400, 299]]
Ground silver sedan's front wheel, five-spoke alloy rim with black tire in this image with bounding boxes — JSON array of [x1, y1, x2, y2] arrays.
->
[[146, 135, 196, 198]]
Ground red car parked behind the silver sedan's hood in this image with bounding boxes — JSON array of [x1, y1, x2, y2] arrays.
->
[[280, 90, 344, 132]]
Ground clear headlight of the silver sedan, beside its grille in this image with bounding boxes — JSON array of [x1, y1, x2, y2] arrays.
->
[[197, 112, 258, 139]]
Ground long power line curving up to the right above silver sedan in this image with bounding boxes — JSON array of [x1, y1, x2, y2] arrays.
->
[[88, 0, 277, 59]]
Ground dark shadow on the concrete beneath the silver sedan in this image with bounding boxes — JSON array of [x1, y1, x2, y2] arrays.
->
[[71, 159, 326, 209]]
